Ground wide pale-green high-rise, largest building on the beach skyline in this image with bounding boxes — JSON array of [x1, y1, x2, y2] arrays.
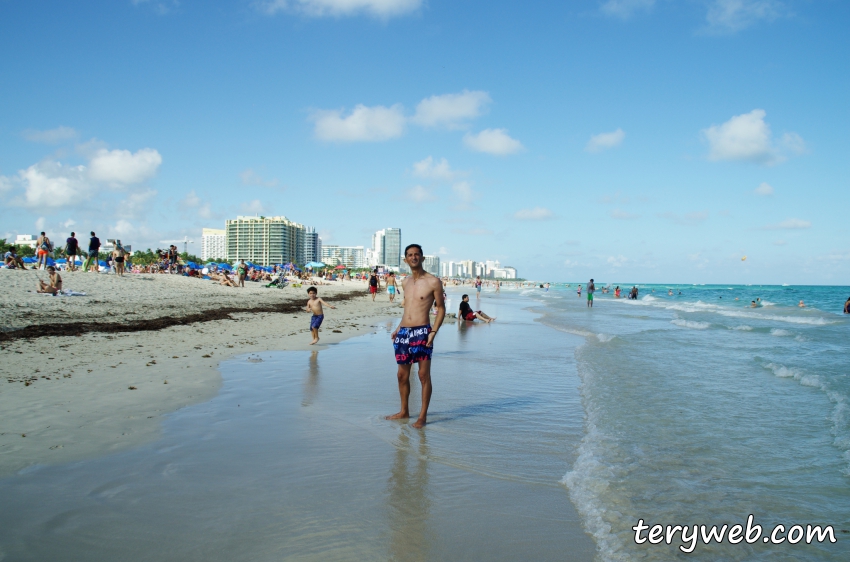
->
[[225, 216, 309, 265]]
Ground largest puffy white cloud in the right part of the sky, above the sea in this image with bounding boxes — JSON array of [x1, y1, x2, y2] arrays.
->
[[702, 109, 805, 165]]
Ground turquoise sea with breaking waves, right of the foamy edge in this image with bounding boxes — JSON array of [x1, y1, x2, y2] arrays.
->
[[527, 284, 850, 560]]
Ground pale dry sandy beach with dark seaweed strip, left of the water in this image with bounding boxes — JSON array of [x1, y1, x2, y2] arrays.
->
[[0, 270, 401, 476]]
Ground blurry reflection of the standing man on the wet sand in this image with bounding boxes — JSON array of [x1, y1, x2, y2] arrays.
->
[[387, 427, 434, 562]]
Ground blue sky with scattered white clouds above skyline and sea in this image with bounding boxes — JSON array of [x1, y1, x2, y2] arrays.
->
[[0, 0, 850, 285]]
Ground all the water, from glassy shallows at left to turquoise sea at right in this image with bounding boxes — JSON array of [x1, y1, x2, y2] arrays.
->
[[0, 284, 850, 561]]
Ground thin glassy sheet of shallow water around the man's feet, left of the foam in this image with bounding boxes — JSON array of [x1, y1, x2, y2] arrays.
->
[[0, 295, 595, 561]]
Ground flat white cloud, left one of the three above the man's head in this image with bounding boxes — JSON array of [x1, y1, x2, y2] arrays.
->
[[312, 104, 405, 142]]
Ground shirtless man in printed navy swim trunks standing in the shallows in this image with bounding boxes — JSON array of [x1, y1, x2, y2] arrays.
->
[[387, 244, 446, 429]]
